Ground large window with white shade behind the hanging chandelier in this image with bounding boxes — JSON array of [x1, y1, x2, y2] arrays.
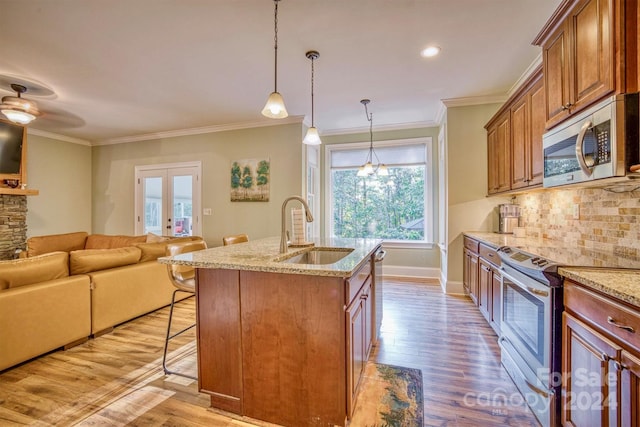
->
[[326, 138, 433, 246]]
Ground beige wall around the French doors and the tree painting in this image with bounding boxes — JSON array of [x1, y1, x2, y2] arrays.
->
[[92, 124, 302, 246]]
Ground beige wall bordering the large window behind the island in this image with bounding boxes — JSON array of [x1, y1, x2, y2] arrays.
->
[[321, 127, 440, 277]]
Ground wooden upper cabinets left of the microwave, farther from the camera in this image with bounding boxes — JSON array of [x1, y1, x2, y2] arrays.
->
[[485, 68, 545, 194]]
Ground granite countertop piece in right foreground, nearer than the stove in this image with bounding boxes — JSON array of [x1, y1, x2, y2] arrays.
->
[[558, 267, 640, 308]]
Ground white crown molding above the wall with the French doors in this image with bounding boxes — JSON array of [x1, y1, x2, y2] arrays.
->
[[91, 116, 304, 145]]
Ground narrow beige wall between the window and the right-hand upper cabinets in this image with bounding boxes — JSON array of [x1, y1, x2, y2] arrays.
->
[[443, 104, 508, 293]]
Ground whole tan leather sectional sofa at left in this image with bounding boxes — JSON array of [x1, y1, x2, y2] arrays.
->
[[0, 232, 201, 370]]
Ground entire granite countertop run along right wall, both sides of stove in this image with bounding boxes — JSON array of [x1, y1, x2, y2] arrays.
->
[[464, 231, 640, 308]]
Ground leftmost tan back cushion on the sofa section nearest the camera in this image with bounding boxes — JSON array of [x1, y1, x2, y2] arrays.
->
[[0, 252, 69, 289]]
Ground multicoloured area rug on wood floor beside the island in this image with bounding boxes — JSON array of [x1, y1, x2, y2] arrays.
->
[[350, 362, 424, 427]]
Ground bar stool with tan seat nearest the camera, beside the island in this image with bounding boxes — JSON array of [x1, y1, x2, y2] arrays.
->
[[162, 240, 207, 380]]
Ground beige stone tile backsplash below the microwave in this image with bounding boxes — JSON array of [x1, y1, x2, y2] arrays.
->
[[515, 183, 640, 258]]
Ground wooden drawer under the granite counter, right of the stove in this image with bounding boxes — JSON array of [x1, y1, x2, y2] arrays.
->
[[564, 280, 640, 351]]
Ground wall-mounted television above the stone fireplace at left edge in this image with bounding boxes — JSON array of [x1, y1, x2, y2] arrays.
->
[[0, 120, 27, 185]]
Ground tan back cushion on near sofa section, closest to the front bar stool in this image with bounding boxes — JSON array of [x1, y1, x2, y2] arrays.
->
[[69, 246, 141, 274]]
